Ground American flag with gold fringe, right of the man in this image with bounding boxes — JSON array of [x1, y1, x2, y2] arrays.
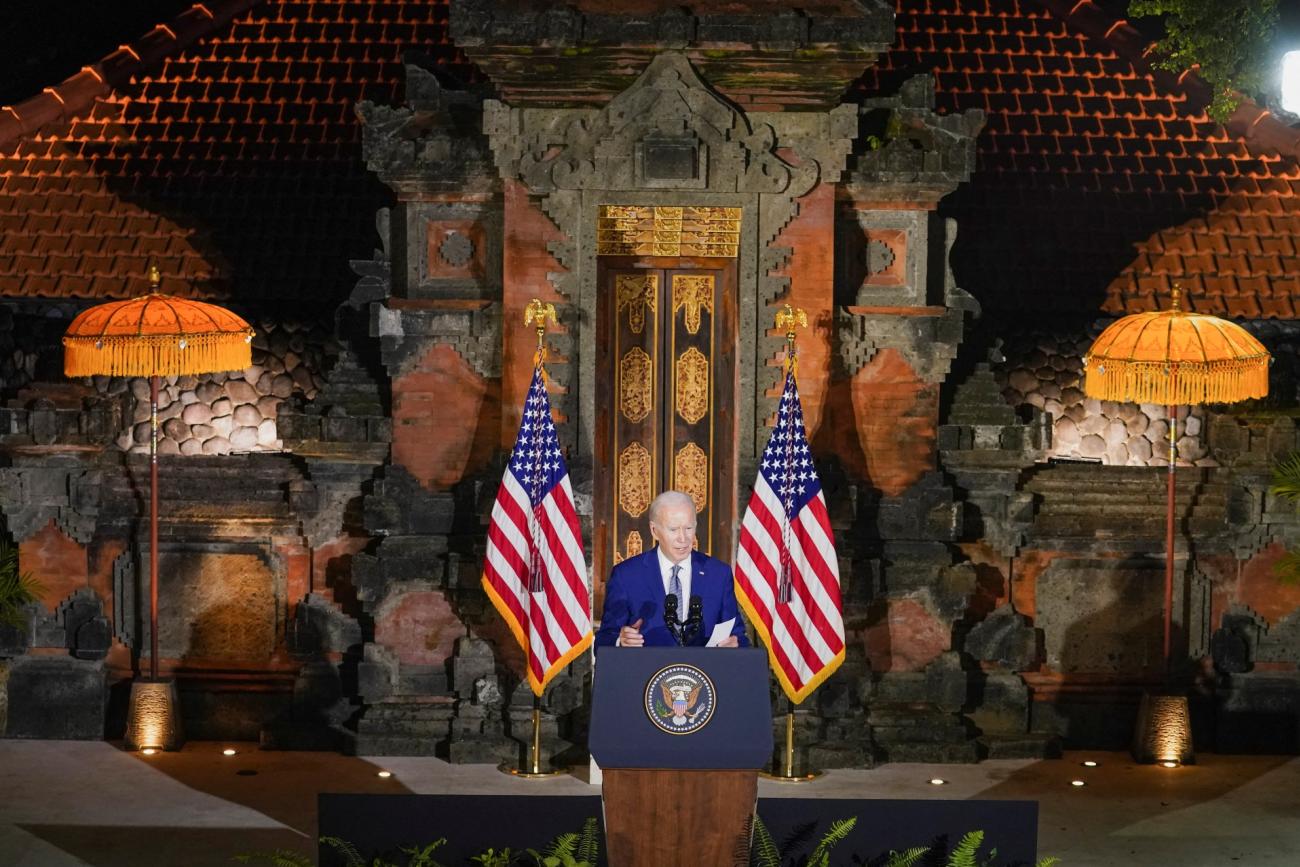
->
[[736, 369, 844, 705]]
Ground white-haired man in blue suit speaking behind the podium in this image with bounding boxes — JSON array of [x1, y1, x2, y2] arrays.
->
[[595, 491, 749, 647]]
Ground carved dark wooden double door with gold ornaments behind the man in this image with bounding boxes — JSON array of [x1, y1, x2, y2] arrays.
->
[[594, 259, 736, 592]]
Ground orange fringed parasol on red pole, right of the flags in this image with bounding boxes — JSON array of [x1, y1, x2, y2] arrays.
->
[[1083, 286, 1271, 673]]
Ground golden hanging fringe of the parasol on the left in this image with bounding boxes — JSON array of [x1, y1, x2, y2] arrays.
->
[[64, 330, 252, 377]]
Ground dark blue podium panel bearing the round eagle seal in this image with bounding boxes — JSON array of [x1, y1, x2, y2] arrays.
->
[[588, 647, 772, 770]]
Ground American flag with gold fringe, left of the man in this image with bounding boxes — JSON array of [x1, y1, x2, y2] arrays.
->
[[482, 364, 592, 695]]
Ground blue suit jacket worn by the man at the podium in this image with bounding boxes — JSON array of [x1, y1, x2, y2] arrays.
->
[[595, 547, 749, 647]]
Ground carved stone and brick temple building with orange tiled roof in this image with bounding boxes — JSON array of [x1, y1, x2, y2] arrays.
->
[[0, 0, 1300, 767]]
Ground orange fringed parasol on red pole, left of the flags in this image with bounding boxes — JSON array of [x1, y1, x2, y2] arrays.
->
[[64, 268, 254, 681]]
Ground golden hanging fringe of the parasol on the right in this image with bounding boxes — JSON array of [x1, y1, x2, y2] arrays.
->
[[1083, 355, 1269, 406]]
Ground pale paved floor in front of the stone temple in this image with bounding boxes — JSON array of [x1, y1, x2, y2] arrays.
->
[[0, 741, 1300, 867]]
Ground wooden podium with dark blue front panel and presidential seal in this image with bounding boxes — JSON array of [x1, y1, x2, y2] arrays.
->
[[589, 647, 772, 867]]
